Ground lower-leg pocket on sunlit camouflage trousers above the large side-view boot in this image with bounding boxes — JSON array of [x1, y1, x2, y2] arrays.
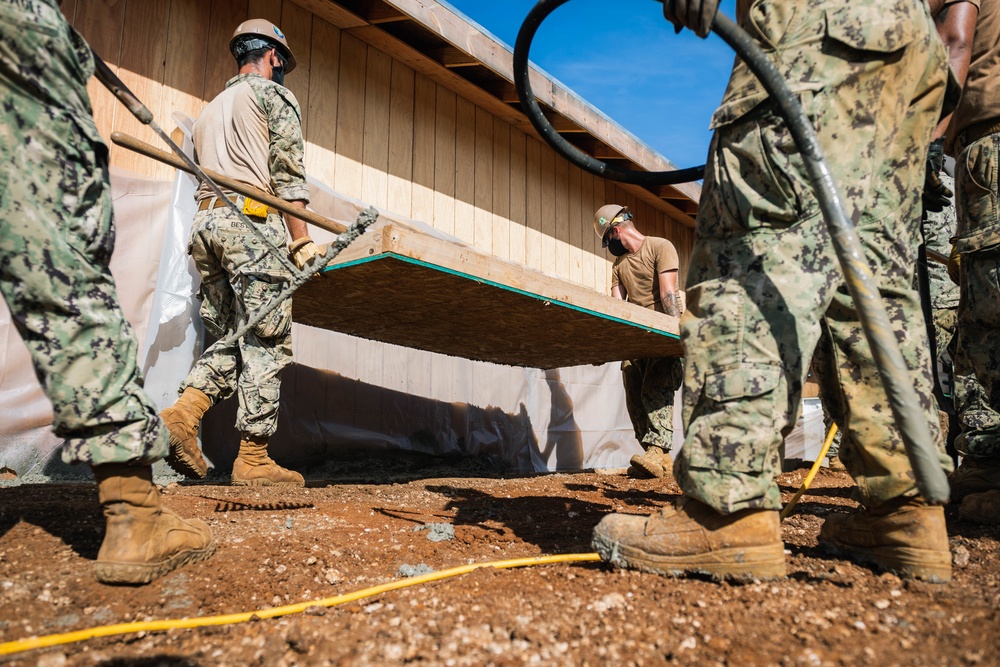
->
[[686, 365, 785, 473]]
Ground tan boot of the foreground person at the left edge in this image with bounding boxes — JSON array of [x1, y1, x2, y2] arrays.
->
[[93, 463, 215, 584]]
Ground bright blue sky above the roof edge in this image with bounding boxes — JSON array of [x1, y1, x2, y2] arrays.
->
[[448, 0, 735, 167]]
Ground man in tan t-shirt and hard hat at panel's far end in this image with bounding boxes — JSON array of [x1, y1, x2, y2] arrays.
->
[[594, 204, 684, 478]]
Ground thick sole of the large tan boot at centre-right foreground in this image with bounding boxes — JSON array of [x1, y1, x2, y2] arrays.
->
[[593, 533, 785, 581]]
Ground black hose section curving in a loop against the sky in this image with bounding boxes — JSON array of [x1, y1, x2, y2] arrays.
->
[[514, 0, 705, 188]]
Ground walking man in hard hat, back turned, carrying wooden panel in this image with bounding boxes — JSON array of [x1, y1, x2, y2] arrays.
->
[[162, 19, 325, 486]]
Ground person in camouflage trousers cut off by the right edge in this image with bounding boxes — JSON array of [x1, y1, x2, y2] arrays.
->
[[945, 0, 1000, 523]]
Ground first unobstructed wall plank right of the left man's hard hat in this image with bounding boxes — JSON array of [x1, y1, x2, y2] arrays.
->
[[303, 17, 341, 188]]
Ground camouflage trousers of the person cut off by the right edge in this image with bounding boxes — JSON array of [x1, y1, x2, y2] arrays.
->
[[955, 133, 1000, 459]]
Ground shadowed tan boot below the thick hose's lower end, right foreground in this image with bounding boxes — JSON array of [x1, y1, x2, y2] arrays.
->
[[819, 497, 951, 583]]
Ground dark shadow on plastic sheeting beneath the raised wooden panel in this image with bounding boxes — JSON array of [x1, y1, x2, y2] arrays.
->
[[201, 364, 583, 482]]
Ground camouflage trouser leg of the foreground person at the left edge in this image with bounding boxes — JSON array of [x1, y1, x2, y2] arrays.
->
[[0, 0, 167, 465]]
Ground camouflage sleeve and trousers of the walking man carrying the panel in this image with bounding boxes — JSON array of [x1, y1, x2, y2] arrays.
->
[[181, 74, 309, 438]]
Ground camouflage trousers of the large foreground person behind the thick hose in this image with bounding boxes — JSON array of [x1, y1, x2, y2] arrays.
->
[[675, 0, 950, 514]]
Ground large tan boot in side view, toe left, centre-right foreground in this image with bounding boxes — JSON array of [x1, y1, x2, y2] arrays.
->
[[592, 498, 785, 580]]
